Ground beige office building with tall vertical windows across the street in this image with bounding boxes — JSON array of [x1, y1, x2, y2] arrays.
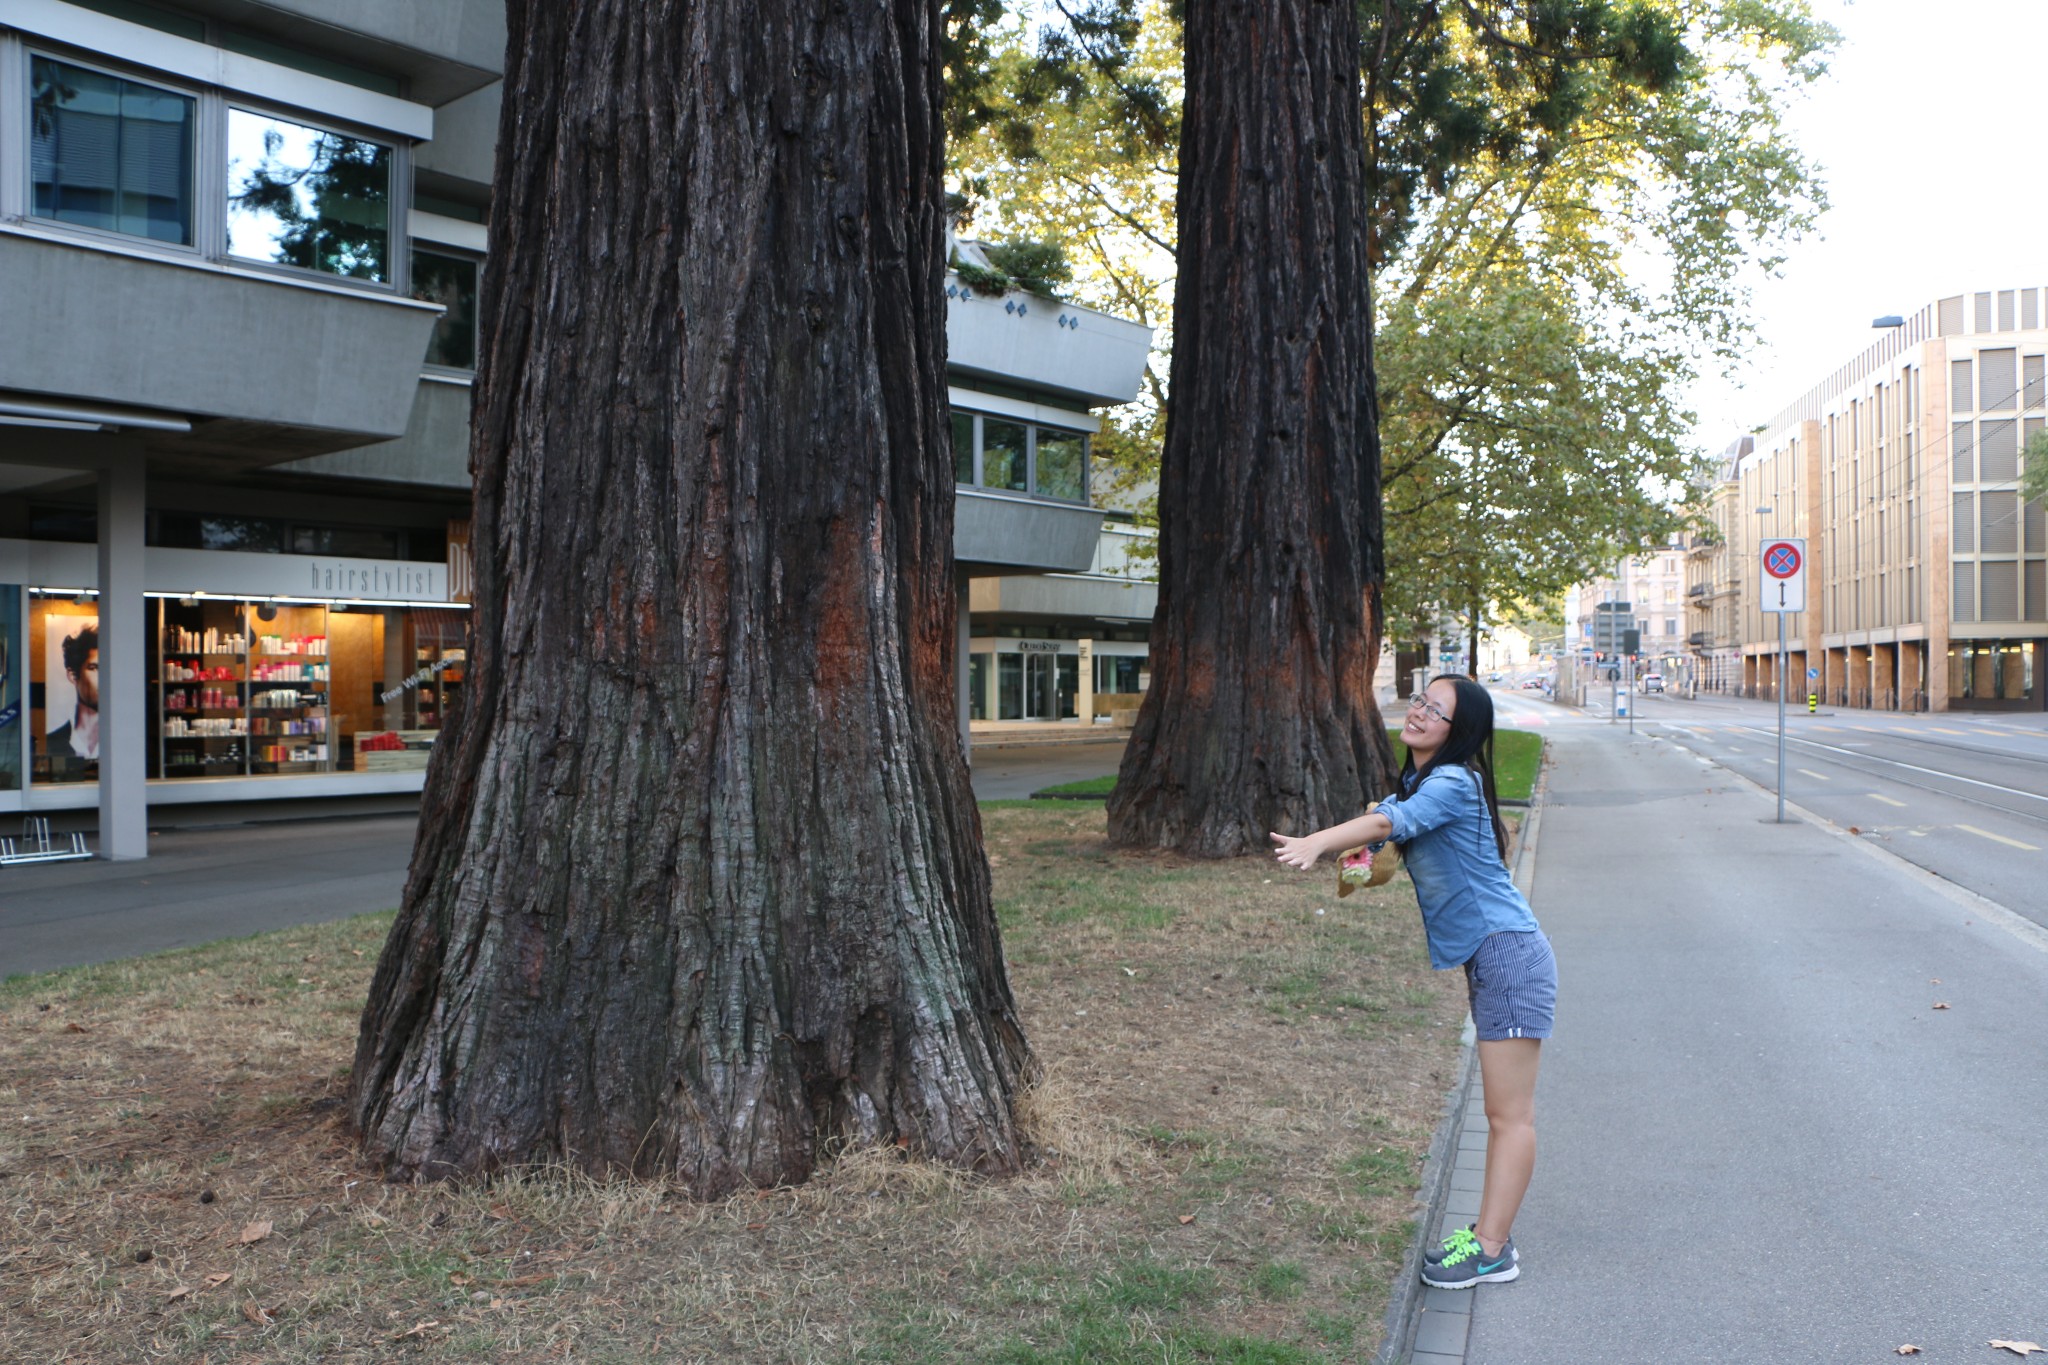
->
[[1688, 289, 2048, 710]]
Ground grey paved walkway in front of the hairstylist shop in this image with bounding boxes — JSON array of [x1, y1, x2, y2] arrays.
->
[[0, 743, 1122, 976]]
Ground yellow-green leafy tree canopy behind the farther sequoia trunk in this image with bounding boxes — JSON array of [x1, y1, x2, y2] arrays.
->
[[950, 0, 1835, 630]]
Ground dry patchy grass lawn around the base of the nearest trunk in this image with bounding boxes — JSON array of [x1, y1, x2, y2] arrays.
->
[[0, 802, 1464, 1365]]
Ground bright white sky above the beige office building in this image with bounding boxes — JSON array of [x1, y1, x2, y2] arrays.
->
[[1690, 0, 2048, 452]]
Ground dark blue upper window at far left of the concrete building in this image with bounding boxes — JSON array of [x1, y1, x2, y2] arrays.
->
[[29, 57, 199, 246]]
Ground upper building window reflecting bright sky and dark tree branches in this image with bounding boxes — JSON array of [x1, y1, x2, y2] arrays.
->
[[227, 108, 391, 284]]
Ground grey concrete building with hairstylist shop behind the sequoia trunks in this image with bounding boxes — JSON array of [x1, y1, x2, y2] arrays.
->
[[0, 0, 1151, 857]]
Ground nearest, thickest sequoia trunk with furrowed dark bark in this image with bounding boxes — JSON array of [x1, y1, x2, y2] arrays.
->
[[350, 0, 1026, 1197]]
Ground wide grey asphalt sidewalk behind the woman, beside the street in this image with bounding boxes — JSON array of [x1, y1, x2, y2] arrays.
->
[[1466, 726, 2048, 1365]]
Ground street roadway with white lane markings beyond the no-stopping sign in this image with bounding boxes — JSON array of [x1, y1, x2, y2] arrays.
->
[[1605, 698, 2048, 925]]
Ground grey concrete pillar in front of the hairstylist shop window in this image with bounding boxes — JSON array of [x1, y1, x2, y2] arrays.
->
[[96, 450, 150, 860]]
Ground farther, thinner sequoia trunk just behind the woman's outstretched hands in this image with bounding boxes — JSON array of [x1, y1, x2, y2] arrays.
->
[[1110, 0, 1393, 857]]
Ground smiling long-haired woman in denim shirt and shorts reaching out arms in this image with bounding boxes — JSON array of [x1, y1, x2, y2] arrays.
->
[[1274, 675, 1556, 1289]]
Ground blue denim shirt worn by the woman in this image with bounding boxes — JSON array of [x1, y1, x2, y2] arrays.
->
[[1380, 763, 1538, 972]]
